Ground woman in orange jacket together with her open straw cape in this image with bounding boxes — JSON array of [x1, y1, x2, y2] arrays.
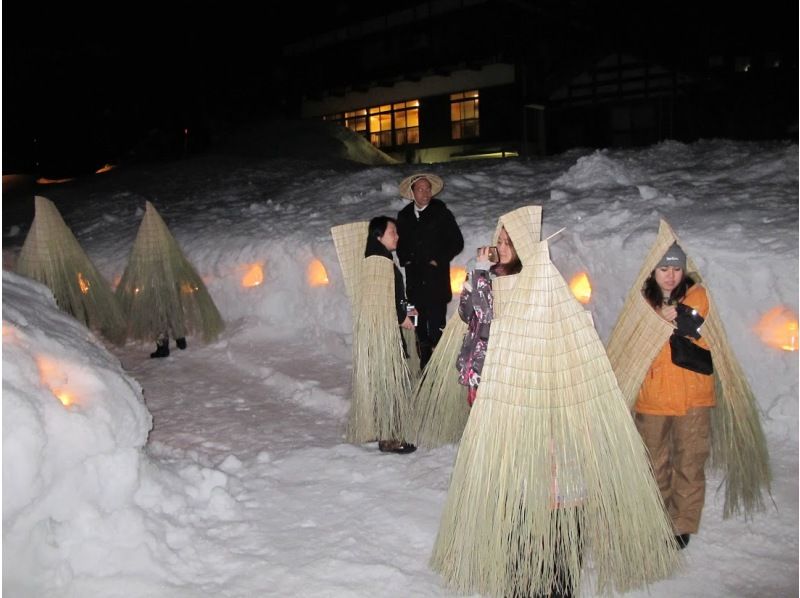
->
[[608, 220, 770, 548]]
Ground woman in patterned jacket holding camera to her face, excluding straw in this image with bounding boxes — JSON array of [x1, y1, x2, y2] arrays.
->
[[456, 228, 522, 407]]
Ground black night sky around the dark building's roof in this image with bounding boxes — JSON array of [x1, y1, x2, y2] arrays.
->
[[3, 0, 798, 176]]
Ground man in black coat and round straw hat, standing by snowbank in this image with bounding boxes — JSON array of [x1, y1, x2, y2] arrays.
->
[[397, 174, 464, 368]]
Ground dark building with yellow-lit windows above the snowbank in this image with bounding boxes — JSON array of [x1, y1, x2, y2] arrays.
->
[[276, 0, 797, 163]]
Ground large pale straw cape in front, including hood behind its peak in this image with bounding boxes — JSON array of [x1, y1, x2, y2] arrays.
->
[[431, 207, 680, 596]]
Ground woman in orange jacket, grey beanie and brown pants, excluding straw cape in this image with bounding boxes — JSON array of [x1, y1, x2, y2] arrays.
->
[[634, 243, 715, 549]]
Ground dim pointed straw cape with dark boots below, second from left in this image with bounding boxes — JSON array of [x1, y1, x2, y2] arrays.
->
[[116, 201, 225, 341]]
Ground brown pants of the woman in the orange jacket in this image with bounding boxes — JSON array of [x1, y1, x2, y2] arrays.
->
[[635, 407, 711, 534]]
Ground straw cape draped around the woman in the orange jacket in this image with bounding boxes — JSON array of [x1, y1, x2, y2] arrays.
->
[[608, 219, 771, 519]]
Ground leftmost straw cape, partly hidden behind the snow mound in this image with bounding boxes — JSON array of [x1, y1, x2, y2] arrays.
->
[[16, 196, 125, 344]]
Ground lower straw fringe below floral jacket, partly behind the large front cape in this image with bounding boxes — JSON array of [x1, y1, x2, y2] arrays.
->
[[411, 313, 469, 448]]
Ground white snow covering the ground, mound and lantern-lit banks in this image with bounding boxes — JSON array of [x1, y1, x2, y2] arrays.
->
[[2, 133, 798, 598]]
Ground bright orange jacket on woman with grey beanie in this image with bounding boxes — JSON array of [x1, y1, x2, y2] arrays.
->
[[634, 284, 715, 415]]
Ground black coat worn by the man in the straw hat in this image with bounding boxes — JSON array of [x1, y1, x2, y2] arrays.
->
[[397, 198, 464, 307]]
